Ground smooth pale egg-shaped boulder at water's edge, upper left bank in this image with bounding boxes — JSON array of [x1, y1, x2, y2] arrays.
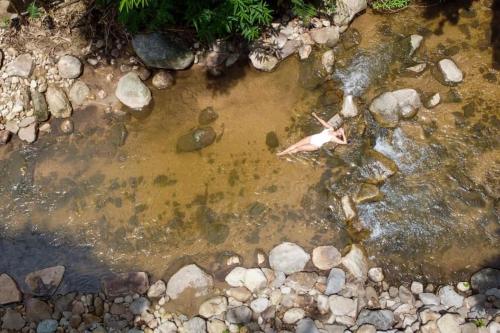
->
[[115, 72, 151, 109]]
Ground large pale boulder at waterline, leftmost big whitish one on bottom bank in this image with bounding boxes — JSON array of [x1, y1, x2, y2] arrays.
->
[[167, 264, 214, 299]]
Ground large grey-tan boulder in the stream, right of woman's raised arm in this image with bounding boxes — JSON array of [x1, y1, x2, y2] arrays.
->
[[370, 89, 422, 128]]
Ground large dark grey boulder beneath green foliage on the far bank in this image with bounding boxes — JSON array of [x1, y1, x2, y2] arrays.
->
[[132, 32, 194, 70]]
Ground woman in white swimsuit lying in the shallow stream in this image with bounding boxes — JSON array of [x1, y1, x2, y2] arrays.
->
[[276, 112, 347, 156]]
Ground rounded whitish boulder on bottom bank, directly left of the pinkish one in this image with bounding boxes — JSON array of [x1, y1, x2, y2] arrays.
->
[[269, 242, 310, 274]]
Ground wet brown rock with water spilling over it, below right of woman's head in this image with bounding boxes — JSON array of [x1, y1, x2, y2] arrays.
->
[[360, 149, 398, 184]]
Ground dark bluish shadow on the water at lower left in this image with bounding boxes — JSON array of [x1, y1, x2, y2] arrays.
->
[[0, 227, 112, 294]]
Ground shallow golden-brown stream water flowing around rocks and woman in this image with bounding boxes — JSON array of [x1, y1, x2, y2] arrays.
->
[[0, 1, 500, 290]]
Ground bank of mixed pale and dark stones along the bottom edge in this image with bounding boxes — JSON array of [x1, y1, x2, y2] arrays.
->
[[0, 243, 500, 333]]
